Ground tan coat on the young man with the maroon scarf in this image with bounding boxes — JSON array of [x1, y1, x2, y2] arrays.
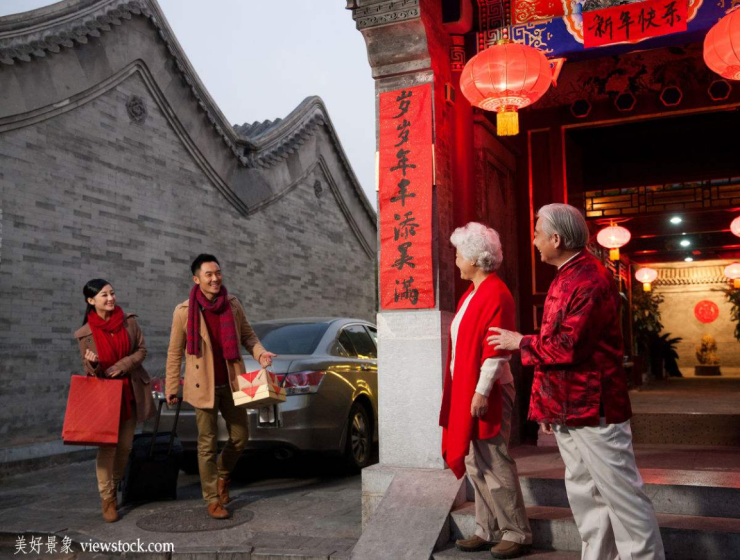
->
[[165, 296, 265, 408]]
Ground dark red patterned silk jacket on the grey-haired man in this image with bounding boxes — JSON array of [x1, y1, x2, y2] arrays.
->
[[520, 251, 632, 426]]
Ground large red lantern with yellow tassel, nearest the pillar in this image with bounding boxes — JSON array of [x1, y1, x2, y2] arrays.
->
[[460, 39, 552, 136]]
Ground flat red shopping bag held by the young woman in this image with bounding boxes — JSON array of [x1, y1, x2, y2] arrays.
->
[[62, 375, 123, 446]]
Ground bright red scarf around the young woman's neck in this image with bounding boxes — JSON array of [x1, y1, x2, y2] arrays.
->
[[87, 305, 134, 422]]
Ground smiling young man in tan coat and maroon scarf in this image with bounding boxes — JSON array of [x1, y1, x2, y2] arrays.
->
[[165, 254, 275, 519]]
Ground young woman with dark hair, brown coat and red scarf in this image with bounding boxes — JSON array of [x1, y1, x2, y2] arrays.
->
[[75, 278, 155, 523]]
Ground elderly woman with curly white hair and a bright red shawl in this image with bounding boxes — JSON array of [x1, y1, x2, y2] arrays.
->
[[440, 222, 532, 558]]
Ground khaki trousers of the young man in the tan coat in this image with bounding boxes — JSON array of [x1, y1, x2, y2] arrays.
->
[[195, 385, 249, 504]]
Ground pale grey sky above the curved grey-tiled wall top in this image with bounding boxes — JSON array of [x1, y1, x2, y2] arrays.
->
[[0, 0, 376, 207]]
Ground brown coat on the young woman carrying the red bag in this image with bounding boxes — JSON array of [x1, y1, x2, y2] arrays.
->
[[75, 313, 156, 422]]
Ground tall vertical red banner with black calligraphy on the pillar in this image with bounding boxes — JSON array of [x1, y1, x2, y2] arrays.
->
[[378, 84, 434, 309]]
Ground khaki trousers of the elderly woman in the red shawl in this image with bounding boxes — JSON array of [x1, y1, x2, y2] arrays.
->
[[465, 383, 532, 544]]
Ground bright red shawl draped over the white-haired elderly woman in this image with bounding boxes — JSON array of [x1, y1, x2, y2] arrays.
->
[[439, 274, 516, 478]]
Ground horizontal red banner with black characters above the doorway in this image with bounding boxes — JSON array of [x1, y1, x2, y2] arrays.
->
[[583, 0, 688, 49]]
